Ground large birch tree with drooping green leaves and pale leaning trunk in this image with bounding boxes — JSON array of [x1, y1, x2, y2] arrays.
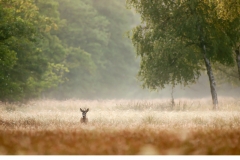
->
[[127, 0, 238, 109]]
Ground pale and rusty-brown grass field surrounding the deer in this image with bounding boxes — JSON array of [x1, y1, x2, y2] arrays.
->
[[0, 97, 240, 155]]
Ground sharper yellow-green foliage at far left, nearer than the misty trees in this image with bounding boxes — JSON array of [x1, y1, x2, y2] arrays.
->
[[0, 0, 62, 101]]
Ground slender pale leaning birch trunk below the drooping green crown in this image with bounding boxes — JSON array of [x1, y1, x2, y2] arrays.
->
[[203, 45, 218, 110]]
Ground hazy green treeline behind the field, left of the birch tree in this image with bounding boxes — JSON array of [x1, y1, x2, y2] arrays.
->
[[0, 0, 141, 102]]
